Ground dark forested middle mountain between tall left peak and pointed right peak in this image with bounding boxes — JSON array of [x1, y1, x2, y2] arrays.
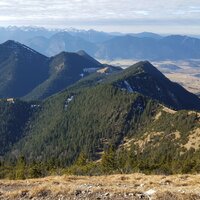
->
[[24, 52, 102, 100]]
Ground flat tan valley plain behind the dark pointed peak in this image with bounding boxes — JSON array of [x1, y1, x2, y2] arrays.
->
[[100, 59, 200, 96]]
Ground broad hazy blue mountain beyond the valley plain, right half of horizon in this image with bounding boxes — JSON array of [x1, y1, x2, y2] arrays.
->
[[95, 35, 200, 60]]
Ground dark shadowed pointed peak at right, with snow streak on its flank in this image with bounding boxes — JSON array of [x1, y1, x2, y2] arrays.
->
[[111, 61, 200, 110]]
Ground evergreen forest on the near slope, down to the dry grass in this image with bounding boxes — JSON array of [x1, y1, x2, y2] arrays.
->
[[0, 84, 200, 179]]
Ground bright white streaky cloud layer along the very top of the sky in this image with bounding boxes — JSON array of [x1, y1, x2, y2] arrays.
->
[[0, 0, 199, 19]]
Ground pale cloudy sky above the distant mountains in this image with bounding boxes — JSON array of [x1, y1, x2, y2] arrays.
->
[[0, 0, 200, 35]]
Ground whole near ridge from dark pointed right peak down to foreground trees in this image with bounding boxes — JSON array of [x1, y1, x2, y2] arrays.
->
[[0, 61, 200, 178]]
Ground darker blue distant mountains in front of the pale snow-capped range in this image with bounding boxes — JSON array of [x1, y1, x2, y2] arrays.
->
[[27, 32, 200, 60]]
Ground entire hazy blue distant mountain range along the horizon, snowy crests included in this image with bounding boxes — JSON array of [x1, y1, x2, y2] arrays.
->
[[0, 27, 200, 60]]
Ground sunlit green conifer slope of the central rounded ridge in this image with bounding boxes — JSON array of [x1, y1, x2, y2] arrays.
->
[[12, 84, 159, 164]]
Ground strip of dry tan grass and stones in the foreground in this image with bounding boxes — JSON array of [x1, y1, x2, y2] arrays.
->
[[0, 174, 200, 200]]
